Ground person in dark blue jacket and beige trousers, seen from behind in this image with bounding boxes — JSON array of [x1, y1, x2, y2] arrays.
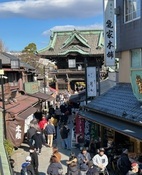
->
[[45, 119, 55, 148]]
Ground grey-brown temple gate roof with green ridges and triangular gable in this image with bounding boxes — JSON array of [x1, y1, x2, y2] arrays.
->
[[38, 30, 104, 56]]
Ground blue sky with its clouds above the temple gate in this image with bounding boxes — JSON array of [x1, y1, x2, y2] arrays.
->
[[0, 0, 103, 51]]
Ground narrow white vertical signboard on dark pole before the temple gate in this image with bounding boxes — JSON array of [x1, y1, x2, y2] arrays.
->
[[86, 67, 96, 97]]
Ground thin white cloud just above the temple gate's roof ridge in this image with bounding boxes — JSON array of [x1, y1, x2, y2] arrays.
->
[[42, 24, 103, 35]]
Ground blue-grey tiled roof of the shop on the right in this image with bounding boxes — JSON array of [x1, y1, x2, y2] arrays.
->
[[86, 83, 142, 123]]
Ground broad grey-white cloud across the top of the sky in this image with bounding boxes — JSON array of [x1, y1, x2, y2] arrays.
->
[[0, 0, 103, 19]]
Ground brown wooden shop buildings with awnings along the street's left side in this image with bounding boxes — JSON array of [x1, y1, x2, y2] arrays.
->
[[0, 53, 52, 147]]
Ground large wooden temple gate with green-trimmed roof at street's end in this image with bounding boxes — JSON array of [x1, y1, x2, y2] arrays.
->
[[38, 30, 104, 91]]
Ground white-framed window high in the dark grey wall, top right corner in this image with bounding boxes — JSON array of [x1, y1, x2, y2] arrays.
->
[[124, 0, 141, 22]]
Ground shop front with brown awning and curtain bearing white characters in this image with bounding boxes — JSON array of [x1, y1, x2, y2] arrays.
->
[[6, 94, 39, 147]]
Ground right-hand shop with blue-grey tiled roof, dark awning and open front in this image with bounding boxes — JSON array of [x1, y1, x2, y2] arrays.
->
[[79, 84, 142, 153]]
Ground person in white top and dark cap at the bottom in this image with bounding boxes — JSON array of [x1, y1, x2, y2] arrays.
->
[[92, 148, 108, 175]]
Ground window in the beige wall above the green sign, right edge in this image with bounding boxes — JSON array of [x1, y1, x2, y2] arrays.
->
[[131, 49, 142, 68]]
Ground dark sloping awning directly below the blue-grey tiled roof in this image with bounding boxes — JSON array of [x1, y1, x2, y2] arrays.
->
[[79, 111, 142, 140]]
